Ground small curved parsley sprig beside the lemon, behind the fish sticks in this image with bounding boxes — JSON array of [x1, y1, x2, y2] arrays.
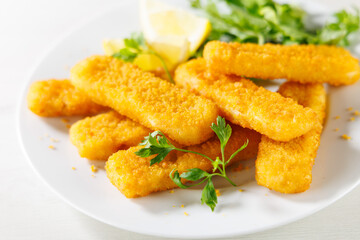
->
[[112, 33, 175, 83]]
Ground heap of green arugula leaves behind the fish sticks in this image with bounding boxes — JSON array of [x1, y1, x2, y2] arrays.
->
[[190, 0, 360, 56]]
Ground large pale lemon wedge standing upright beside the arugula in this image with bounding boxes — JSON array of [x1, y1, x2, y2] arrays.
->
[[140, 0, 211, 66]]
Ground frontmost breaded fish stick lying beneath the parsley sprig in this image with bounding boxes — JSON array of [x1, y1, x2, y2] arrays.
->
[[106, 126, 261, 198]]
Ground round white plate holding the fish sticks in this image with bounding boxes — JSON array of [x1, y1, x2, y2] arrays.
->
[[18, 1, 360, 238]]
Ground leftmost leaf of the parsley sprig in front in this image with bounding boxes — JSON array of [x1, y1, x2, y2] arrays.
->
[[135, 131, 176, 166]]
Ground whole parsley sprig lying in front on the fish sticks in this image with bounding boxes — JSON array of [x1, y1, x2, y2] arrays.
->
[[135, 116, 249, 211]]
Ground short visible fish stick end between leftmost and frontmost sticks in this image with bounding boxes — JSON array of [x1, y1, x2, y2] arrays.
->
[[70, 111, 150, 160]]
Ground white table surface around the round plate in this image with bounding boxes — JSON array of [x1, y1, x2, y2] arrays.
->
[[0, 0, 360, 240]]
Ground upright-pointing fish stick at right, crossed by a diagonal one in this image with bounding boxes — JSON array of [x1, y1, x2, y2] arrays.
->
[[256, 82, 326, 193]]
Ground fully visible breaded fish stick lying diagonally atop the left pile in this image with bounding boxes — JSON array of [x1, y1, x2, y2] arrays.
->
[[71, 56, 218, 145]]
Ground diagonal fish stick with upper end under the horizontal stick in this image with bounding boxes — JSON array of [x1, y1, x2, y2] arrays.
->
[[175, 58, 316, 141]]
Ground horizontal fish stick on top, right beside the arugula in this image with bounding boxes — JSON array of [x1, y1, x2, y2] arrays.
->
[[204, 41, 360, 86]]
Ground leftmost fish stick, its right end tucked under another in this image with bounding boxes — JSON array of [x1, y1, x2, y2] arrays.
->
[[27, 79, 107, 117]]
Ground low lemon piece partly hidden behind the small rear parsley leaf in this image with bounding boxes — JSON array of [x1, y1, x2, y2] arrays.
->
[[103, 39, 163, 71]]
